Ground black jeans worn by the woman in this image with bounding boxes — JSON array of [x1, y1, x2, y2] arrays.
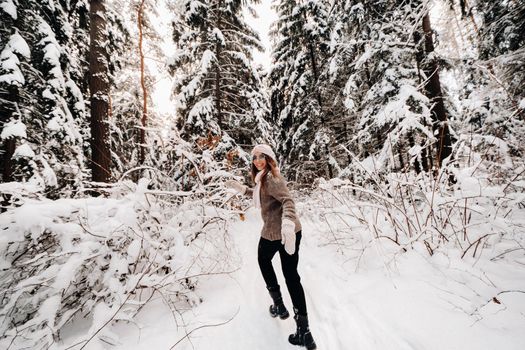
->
[[258, 231, 306, 316]]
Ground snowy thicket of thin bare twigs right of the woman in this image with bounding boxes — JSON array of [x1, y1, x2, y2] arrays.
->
[[304, 145, 525, 265]]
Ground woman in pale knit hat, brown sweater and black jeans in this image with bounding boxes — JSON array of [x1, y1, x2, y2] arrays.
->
[[225, 144, 316, 350]]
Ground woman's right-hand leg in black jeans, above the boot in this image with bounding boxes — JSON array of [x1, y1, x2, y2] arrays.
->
[[279, 232, 307, 316]]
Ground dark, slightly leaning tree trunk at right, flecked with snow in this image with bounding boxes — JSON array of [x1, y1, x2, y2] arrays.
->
[[420, 13, 452, 167]]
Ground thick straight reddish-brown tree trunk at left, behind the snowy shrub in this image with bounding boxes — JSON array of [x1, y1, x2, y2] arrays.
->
[[89, 0, 111, 182]]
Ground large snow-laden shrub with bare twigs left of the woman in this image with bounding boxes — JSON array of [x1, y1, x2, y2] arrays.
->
[[0, 179, 232, 349]]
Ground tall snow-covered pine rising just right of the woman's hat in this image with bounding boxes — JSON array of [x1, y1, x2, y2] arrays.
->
[[269, 0, 335, 181]]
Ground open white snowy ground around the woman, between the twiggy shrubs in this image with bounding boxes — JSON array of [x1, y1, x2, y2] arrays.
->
[[79, 203, 525, 350]]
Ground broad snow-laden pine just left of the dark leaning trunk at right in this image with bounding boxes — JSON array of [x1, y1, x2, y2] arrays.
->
[[326, 1, 436, 175]]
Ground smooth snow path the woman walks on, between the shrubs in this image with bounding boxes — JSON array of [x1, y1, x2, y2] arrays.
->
[[108, 209, 525, 350]]
